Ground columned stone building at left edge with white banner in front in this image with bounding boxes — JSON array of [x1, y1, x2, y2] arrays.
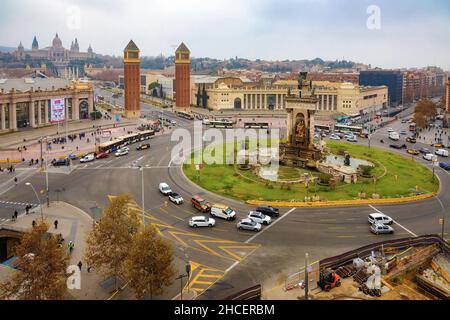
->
[[0, 78, 94, 132]]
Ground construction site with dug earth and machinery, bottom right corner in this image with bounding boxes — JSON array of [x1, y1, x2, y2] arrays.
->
[[284, 236, 450, 300]]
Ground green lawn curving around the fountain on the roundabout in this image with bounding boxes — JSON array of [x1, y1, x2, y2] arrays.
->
[[183, 141, 439, 201]]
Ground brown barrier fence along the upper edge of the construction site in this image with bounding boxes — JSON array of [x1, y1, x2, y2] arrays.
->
[[284, 235, 450, 291]]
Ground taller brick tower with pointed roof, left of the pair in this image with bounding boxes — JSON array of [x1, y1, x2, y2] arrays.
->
[[123, 40, 141, 119]]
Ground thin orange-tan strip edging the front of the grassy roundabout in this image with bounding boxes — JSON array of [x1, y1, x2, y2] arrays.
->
[[247, 193, 436, 208]]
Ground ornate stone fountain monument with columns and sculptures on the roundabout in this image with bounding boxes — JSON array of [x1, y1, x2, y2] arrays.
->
[[280, 72, 323, 168]]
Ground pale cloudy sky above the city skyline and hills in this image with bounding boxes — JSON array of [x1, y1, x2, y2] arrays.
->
[[0, 0, 450, 70]]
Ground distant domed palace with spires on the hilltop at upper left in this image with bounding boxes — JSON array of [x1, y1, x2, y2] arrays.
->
[[14, 33, 96, 64]]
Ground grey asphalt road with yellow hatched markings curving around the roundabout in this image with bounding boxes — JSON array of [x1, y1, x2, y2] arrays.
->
[[0, 90, 450, 299]]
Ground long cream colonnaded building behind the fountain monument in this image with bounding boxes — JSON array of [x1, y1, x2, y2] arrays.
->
[[191, 77, 388, 115]]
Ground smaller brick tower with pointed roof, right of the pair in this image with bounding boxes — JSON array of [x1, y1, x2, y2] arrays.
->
[[175, 43, 191, 111]]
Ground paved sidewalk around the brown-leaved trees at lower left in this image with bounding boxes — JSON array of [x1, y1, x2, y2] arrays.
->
[[0, 202, 113, 300]]
